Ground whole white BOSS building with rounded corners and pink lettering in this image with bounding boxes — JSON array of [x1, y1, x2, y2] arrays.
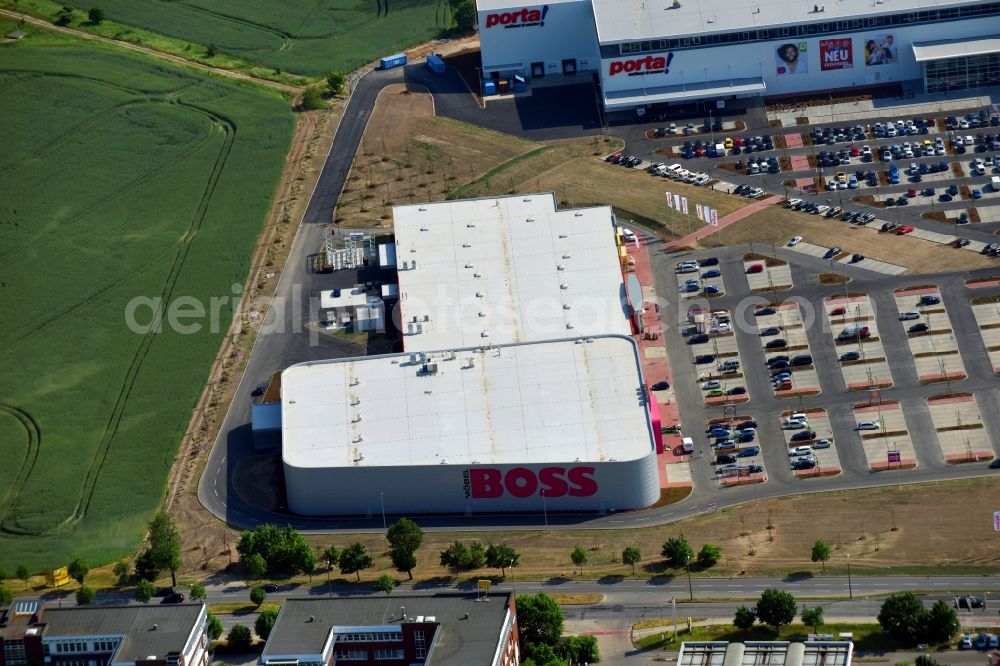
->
[[281, 335, 659, 515]]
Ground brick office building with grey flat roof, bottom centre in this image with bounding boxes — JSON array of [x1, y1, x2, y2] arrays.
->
[[258, 592, 520, 666]]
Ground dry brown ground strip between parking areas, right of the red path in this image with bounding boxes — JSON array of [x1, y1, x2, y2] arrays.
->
[[700, 205, 993, 273]]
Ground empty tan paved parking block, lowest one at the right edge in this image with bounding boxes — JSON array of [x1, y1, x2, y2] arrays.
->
[[927, 393, 993, 463]]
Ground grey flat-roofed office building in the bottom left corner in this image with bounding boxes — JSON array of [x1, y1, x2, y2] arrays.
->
[[0, 601, 209, 666]]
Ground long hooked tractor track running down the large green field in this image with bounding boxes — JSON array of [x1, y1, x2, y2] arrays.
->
[[64, 103, 237, 536]]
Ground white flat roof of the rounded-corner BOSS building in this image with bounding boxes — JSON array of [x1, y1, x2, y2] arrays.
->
[[281, 335, 654, 468]]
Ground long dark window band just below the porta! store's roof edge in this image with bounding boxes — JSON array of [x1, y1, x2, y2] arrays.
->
[[601, 2, 1000, 58]]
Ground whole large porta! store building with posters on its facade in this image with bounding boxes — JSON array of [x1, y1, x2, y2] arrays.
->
[[477, 0, 1000, 112]]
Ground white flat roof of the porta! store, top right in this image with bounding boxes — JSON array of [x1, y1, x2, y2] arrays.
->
[[592, 0, 977, 44]]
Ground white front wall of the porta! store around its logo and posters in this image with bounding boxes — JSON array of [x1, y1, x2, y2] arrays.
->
[[601, 20, 996, 98]]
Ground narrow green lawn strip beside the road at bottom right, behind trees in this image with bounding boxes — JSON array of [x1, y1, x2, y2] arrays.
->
[[635, 623, 939, 651]]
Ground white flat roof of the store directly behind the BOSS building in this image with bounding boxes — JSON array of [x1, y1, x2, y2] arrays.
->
[[393, 193, 631, 351]]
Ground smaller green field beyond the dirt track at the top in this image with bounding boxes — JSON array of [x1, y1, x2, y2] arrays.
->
[[0, 0, 451, 77]]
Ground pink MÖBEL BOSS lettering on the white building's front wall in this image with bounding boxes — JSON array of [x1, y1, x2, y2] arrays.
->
[[464, 467, 597, 499]]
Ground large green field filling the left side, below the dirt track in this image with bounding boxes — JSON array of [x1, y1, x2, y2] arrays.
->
[[0, 20, 294, 571]]
